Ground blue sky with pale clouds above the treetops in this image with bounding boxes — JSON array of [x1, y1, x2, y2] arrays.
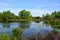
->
[[0, 0, 60, 16]]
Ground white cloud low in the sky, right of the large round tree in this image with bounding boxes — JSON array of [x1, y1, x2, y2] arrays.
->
[[26, 9, 54, 16]]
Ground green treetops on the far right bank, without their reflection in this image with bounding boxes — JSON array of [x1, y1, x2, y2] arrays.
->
[[43, 11, 60, 20]]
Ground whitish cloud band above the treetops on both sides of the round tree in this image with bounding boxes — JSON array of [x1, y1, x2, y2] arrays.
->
[[0, 8, 57, 16]]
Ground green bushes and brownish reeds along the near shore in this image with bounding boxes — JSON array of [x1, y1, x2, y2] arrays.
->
[[0, 28, 60, 40]]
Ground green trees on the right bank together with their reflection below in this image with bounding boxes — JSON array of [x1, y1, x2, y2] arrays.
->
[[43, 11, 60, 29]]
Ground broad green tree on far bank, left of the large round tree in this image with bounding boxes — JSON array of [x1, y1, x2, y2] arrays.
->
[[3, 10, 16, 21]]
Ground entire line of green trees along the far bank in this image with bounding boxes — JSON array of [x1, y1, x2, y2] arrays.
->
[[0, 9, 60, 22]]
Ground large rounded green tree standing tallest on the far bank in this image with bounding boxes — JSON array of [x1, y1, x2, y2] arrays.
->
[[19, 10, 32, 21]]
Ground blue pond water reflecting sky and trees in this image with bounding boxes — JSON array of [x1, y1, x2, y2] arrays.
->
[[0, 21, 60, 37]]
